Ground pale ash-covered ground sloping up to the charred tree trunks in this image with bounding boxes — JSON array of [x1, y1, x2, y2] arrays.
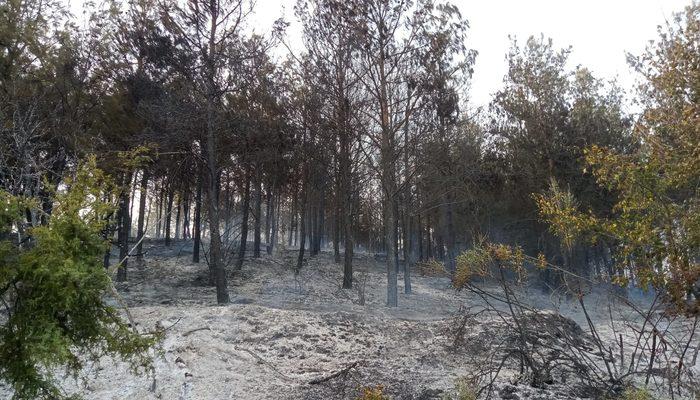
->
[[0, 242, 696, 400]]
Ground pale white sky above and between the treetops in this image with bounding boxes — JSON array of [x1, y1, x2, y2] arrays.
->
[[70, 0, 691, 106]]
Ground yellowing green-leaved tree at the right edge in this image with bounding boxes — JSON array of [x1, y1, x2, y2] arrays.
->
[[539, 3, 700, 314]]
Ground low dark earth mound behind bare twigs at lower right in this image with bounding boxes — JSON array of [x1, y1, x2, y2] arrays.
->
[[450, 310, 605, 398]]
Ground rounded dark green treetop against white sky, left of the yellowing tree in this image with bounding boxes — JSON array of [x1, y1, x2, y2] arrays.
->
[[492, 37, 633, 219]]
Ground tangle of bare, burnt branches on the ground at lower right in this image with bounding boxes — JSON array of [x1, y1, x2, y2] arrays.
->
[[451, 274, 700, 399]]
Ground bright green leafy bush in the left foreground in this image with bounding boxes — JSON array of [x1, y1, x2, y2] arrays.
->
[[0, 160, 159, 399]]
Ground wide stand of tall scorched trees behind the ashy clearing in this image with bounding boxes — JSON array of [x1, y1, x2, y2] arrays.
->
[[0, 0, 700, 307]]
